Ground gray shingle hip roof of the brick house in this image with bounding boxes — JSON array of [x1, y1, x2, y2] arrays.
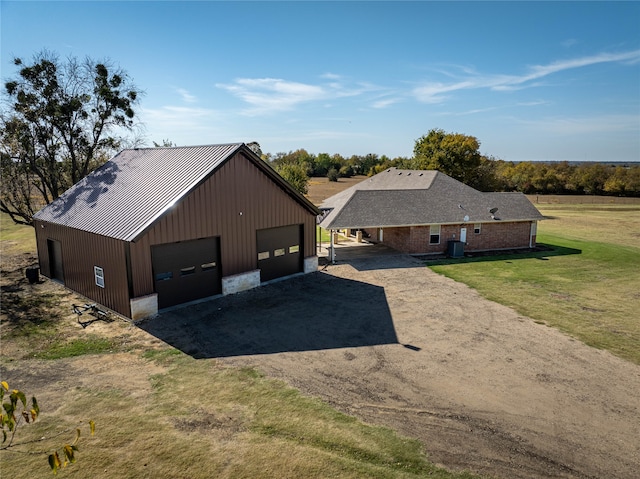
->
[[320, 168, 544, 229]]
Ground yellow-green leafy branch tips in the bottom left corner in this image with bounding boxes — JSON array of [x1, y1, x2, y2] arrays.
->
[[0, 381, 95, 474]]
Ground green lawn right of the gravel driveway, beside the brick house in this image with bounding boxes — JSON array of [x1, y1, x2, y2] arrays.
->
[[429, 205, 640, 364]]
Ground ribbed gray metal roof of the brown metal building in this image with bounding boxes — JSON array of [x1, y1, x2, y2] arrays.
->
[[34, 143, 317, 241]]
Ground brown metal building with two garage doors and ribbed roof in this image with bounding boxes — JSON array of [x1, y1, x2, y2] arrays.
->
[[34, 143, 318, 319]]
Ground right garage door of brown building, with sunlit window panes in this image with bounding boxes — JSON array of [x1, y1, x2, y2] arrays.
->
[[257, 225, 302, 281]]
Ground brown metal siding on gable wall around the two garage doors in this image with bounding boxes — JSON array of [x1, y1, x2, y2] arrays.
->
[[131, 153, 316, 296]]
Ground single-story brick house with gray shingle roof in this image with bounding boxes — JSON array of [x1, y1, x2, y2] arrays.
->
[[320, 168, 544, 254]]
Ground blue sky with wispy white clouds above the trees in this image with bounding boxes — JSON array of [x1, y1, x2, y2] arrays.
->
[[0, 0, 640, 161]]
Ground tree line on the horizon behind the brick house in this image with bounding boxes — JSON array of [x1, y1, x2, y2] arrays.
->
[[262, 129, 640, 197]]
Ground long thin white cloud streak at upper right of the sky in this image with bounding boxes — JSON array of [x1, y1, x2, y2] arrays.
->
[[413, 50, 640, 103]]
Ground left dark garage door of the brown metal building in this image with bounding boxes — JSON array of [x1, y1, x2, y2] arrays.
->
[[151, 238, 222, 308]]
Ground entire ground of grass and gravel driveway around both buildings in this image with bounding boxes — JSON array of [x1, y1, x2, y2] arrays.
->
[[0, 191, 640, 478]]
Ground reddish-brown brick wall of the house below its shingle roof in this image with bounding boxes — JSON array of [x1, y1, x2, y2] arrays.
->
[[367, 221, 535, 254]]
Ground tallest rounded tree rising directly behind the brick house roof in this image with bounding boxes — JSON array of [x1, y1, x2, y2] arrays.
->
[[412, 129, 482, 186]]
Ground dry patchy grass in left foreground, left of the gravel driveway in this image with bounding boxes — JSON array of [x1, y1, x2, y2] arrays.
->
[[0, 218, 476, 479]]
